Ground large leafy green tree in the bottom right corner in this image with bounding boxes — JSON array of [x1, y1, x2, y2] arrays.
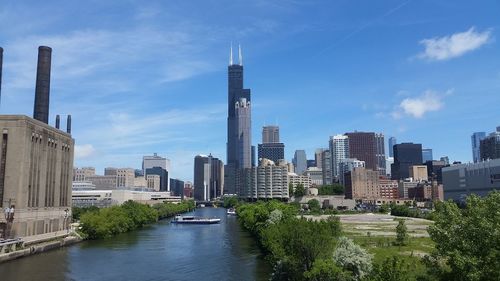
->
[[425, 191, 500, 281]]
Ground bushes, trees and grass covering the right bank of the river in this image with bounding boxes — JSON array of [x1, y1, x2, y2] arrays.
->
[[237, 191, 500, 281]]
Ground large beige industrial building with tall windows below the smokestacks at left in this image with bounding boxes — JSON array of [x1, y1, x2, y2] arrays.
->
[[0, 115, 74, 237]]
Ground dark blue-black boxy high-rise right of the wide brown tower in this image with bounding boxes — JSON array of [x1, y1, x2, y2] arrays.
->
[[391, 143, 422, 180]]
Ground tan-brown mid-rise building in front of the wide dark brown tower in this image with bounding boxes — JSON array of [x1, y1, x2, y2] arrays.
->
[[344, 167, 380, 201]]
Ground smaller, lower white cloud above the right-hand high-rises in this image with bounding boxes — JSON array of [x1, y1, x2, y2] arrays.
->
[[391, 90, 453, 119]]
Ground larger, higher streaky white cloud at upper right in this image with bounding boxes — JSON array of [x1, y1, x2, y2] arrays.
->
[[418, 27, 491, 61]]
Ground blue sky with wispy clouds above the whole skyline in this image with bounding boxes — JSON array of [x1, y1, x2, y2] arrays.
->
[[0, 0, 500, 180]]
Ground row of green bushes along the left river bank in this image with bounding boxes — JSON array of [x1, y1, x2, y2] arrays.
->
[[73, 200, 195, 240]]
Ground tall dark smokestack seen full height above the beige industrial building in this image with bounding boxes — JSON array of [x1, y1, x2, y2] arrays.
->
[[33, 46, 52, 124]]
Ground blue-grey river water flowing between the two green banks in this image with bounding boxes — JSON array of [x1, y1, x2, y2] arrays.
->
[[0, 208, 271, 281]]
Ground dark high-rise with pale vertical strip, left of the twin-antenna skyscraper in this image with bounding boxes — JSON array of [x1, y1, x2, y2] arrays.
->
[[194, 155, 224, 201]]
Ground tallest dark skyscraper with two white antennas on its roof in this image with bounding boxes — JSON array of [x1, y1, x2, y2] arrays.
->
[[225, 46, 252, 194]]
